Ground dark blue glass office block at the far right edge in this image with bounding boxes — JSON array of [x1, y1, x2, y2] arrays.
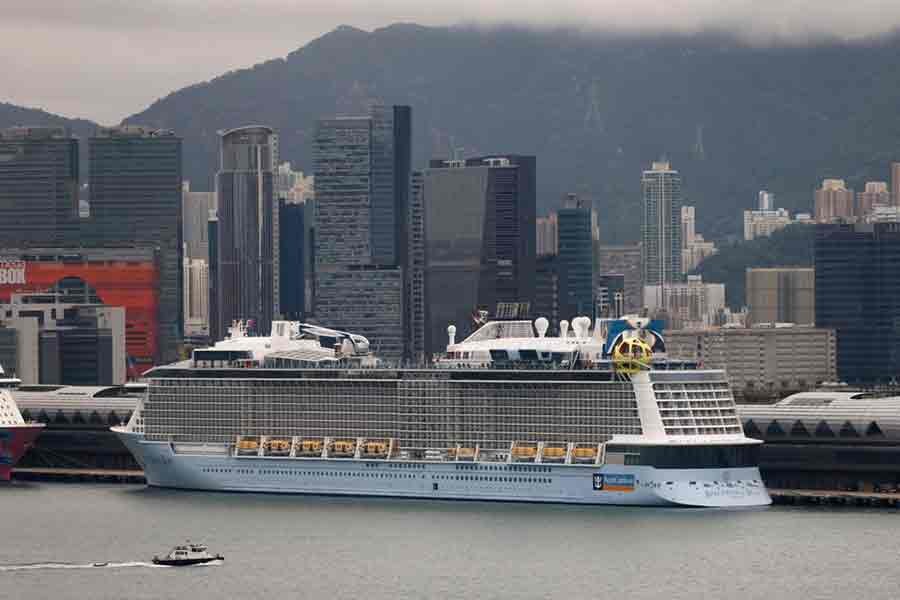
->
[[814, 223, 900, 383]]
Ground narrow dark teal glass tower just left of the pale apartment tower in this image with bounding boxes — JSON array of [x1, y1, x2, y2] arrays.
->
[[557, 194, 594, 319]]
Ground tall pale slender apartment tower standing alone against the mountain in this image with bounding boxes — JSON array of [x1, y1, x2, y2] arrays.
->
[[641, 162, 682, 285]]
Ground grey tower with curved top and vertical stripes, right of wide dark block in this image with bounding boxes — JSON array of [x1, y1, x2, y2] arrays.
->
[[210, 126, 280, 335]]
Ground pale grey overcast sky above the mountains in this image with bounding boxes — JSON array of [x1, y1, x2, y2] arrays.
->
[[0, 0, 900, 124]]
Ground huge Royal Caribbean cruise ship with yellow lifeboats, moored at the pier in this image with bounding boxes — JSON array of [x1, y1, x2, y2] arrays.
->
[[113, 317, 771, 507]]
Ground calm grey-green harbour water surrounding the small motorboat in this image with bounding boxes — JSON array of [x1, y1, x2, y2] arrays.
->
[[0, 482, 900, 600]]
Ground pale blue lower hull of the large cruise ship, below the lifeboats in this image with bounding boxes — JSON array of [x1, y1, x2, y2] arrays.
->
[[114, 428, 771, 508]]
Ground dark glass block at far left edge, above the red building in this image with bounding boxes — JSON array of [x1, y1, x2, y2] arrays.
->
[[0, 127, 79, 248]]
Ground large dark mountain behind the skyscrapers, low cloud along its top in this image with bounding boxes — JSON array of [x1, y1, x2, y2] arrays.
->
[[0, 24, 900, 243]]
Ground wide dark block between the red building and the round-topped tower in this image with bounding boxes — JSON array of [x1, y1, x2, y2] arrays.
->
[[88, 125, 184, 363]]
